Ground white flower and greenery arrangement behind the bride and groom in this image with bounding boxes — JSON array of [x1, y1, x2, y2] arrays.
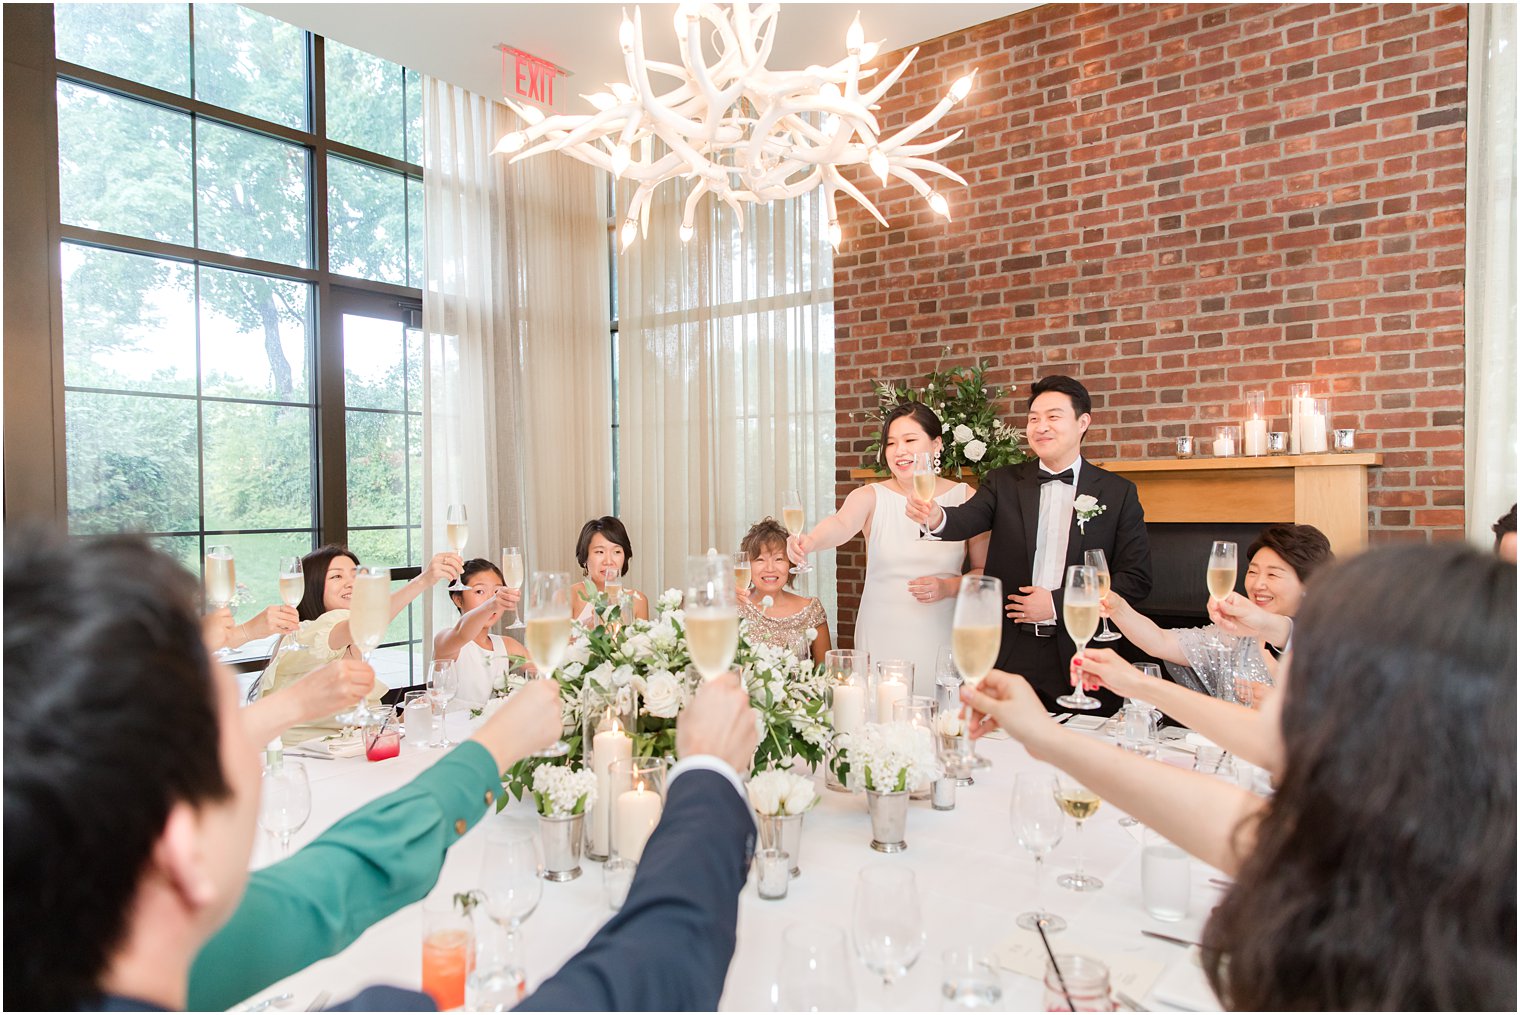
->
[[857, 363, 1029, 479]]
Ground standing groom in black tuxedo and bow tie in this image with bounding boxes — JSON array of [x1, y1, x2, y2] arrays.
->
[[907, 374, 1151, 714]]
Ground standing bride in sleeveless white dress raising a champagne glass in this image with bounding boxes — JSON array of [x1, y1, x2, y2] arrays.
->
[[787, 401, 991, 696]]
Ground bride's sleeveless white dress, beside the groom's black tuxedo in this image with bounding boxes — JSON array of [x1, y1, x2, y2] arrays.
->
[[854, 483, 971, 697]]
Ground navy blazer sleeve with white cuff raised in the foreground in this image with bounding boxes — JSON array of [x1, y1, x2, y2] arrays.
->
[[514, 769, 754, 1012]]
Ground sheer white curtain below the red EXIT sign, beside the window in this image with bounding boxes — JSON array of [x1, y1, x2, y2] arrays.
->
[[423, 77, 613, 640]]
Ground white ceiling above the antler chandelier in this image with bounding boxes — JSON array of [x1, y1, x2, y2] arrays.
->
[[245, 3, 1038, 112]]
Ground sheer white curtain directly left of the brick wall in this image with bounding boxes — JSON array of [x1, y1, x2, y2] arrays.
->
[[617, 185, 836, 628]]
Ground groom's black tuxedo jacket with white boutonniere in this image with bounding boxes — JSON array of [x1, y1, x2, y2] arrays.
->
[[939, 459, 1151, 694]]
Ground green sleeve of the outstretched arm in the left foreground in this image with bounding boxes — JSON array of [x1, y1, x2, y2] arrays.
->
[[188, 743, 502, 1012]]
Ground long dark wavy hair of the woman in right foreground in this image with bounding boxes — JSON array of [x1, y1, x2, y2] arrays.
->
[[1204, 544, 1515, 1012]]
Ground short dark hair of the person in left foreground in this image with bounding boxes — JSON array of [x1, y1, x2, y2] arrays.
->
[[5, 530, 231, 1012]]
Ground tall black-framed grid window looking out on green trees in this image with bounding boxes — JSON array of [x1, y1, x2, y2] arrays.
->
[[53, 3, 423, 685]]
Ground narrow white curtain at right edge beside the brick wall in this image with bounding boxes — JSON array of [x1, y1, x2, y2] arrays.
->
[[1465, 3, 1517, 547]]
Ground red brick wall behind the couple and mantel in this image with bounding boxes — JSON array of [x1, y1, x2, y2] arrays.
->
[[834, 5, 1467, 640]]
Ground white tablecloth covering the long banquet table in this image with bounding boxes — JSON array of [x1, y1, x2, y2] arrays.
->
[[240, 711, 1221, 1010]]
